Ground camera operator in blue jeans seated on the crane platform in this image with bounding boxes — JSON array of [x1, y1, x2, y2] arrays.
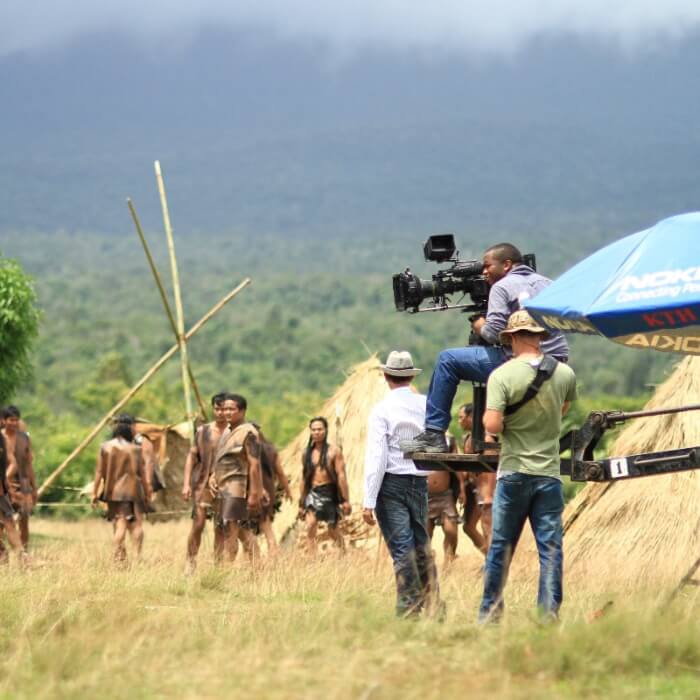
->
[[401, 243, 569, 453]]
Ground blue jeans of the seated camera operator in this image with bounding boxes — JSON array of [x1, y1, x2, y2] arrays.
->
[[425, 345, 506, 432]]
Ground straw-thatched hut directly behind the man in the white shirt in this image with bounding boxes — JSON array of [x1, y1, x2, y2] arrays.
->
[[275, 356, 388, 548]]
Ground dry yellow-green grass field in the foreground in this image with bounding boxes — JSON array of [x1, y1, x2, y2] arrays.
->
[[0, 521, 700, 700]]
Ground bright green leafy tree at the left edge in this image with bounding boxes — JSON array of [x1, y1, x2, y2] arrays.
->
[[0, 254, 40, 402]]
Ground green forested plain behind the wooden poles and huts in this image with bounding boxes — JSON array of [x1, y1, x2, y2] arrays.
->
[[4, 221, 675, 497]]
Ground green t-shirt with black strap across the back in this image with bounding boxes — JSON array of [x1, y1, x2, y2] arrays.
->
[[486, 358, 576, 479]]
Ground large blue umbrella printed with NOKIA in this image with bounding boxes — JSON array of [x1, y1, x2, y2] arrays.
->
[[523, 212, 700, 355]]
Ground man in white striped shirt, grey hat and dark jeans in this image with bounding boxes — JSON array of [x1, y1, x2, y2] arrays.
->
[[362, 351, 437, 617]]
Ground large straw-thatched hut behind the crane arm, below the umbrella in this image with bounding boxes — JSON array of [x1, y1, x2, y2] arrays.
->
[[564, 357, 700, 590]]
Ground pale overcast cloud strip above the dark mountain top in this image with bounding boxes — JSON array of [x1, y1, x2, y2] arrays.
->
[[0, 0, 700, 55]]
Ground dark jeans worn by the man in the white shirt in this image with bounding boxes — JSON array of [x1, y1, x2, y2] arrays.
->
[[374, 474, 437, 616]]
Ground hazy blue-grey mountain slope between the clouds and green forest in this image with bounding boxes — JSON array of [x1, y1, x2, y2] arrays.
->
[[0, 29, 700, 239]]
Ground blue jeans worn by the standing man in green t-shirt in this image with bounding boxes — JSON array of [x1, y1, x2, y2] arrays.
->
[[479, 473, 564, 621]]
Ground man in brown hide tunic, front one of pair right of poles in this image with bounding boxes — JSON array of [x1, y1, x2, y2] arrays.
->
[[209, 394, 263, 561]]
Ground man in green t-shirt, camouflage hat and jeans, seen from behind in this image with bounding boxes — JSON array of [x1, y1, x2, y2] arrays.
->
[[479, 311, 576, 622]]
